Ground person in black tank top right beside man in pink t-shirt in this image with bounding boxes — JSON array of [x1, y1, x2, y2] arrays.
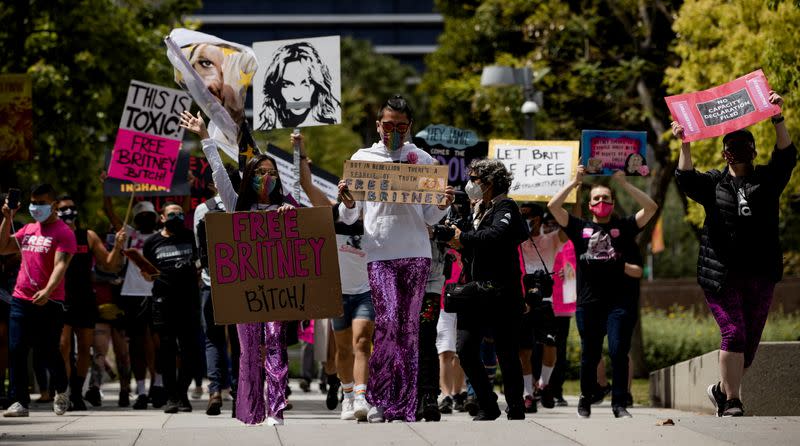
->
[[58, 194, 130, 410]]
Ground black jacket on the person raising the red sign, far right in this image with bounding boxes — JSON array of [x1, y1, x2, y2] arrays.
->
[[675, 144, 797, 293]]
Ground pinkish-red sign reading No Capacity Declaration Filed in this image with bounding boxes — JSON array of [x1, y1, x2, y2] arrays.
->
[[665, 70, 781, 142]]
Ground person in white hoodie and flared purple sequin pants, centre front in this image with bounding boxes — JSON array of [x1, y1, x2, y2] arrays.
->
[[339, 95, 454, 422]]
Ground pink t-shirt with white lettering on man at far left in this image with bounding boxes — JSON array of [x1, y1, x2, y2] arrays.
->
[[14, 220, 78, 301]]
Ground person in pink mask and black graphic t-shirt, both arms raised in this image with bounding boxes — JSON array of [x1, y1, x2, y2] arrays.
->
[[547, 166, 658, 418]]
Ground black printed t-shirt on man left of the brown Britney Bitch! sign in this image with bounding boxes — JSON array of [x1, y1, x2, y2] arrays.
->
[[142, 229, 197, 296]]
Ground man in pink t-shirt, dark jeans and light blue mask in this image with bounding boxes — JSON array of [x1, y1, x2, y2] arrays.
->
[[0, 184, 77, 417]]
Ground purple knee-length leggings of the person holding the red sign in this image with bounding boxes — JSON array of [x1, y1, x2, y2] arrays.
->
[[705, 273, 775, 367]]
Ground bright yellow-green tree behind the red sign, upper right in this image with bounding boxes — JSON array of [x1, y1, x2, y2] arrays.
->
[[666, 0, 800, 274]]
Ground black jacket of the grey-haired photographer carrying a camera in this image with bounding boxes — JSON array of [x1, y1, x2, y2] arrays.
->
[[460, 198, 528, 294]]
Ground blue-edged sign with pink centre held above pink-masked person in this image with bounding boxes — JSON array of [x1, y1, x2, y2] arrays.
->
[[581, 130, 650, 177]]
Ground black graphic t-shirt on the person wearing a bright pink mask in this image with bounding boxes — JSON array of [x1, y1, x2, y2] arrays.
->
[[563, 215, 641, 306]]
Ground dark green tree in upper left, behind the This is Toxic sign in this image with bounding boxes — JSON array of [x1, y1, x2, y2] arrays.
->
[[0, 0, 200, 228]]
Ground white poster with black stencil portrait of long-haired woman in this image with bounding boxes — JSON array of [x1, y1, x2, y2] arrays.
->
[[253, 36, 342, 130]]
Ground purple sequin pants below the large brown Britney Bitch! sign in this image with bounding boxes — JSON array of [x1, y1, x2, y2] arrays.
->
[[236, 322, 289, 424]]
